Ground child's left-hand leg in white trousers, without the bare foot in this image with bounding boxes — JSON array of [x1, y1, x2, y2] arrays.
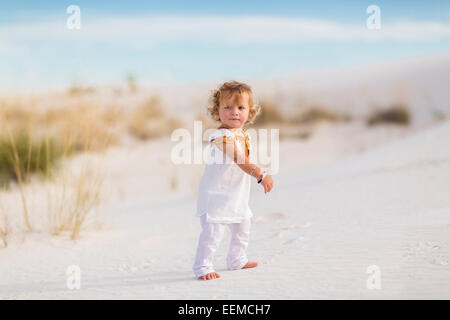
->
[[193, 214, 225, 278]]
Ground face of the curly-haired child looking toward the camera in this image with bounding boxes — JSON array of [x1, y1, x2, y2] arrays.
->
[[219, 92, 250, 128]]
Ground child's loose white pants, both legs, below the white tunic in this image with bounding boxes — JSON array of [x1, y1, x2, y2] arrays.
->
[[193, 214, 250, 278]]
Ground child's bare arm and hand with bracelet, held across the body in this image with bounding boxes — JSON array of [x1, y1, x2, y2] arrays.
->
[[211, 137, 273, 193]]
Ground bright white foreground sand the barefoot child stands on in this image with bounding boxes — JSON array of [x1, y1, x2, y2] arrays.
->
[[0, 117, 450, 299]]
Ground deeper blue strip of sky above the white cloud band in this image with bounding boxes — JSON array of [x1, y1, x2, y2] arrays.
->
[[0, 0, 450, 22]]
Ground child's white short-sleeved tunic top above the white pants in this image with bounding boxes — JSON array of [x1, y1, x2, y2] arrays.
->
[[196, 128, 253, 223]]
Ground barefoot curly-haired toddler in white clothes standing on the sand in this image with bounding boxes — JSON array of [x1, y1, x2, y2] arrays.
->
[[193, 81, 273, 280]]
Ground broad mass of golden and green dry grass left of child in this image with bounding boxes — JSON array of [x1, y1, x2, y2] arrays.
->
[[0, 87, 183, 240]]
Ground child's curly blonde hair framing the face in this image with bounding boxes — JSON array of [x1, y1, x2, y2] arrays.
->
[[208, 80, 261, 123]]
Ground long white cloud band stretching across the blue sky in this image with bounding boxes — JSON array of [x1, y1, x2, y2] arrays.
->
[[0, 15, 450, 45]]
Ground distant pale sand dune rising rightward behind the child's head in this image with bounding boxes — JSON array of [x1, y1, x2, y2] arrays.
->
[[128, 54, 450, 125]]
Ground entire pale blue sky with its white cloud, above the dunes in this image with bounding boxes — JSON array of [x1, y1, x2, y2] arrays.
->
[[0, 0, 450, 91]]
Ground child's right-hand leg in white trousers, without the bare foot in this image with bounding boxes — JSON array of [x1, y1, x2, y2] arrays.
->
[[227, 219, 250, 270]]
